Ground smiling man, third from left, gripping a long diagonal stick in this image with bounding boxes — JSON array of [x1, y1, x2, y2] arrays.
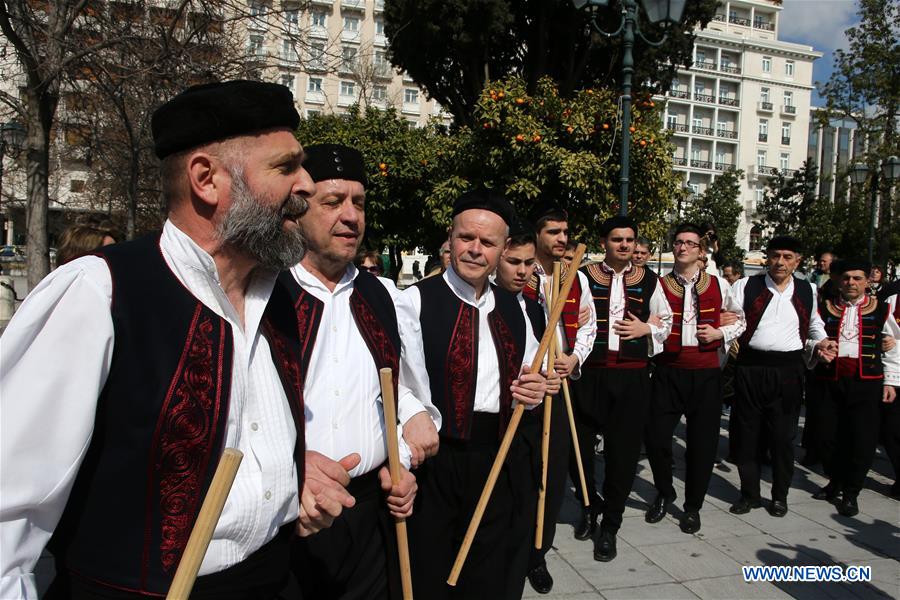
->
[[397, 190, 546, 600]]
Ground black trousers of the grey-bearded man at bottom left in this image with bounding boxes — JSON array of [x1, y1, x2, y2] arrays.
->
[[44, 523, 295, 600]]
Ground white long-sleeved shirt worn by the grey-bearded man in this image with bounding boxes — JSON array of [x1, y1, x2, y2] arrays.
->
[[0, 221, 299, 599]]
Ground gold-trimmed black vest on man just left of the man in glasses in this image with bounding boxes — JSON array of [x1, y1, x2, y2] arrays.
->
[[581, 263, 658, 363]]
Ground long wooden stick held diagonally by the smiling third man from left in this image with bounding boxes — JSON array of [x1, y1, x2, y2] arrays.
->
[[447, 244, 586, 586]]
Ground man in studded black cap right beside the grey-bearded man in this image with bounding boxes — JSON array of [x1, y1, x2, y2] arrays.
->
[[282, 144, 440, 599]]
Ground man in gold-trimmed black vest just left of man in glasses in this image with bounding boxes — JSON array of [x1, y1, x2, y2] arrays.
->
[[569, 216, 672, 562]]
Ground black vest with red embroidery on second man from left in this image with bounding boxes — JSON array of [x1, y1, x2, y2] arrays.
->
[[278, 271, 400, 410]]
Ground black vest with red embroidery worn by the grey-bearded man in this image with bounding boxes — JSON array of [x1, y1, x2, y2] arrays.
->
[[49, 235, 304, 595]]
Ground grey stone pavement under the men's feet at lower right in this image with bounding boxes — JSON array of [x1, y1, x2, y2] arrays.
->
[[524, 412, 900, 600]]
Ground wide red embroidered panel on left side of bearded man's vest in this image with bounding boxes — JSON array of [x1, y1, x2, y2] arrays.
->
[[143, 304, 227, 576]]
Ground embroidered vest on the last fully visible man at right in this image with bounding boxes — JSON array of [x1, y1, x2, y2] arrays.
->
[[816, 296, 890, 380]]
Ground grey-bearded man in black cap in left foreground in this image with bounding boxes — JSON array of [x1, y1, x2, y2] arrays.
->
[[0, 81, 348, 599]]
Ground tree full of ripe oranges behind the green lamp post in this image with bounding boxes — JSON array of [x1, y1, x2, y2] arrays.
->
[[427, 77, 680, 244]]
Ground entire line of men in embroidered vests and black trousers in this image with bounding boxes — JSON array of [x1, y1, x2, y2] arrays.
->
[[0, 82, 900, 599]]
